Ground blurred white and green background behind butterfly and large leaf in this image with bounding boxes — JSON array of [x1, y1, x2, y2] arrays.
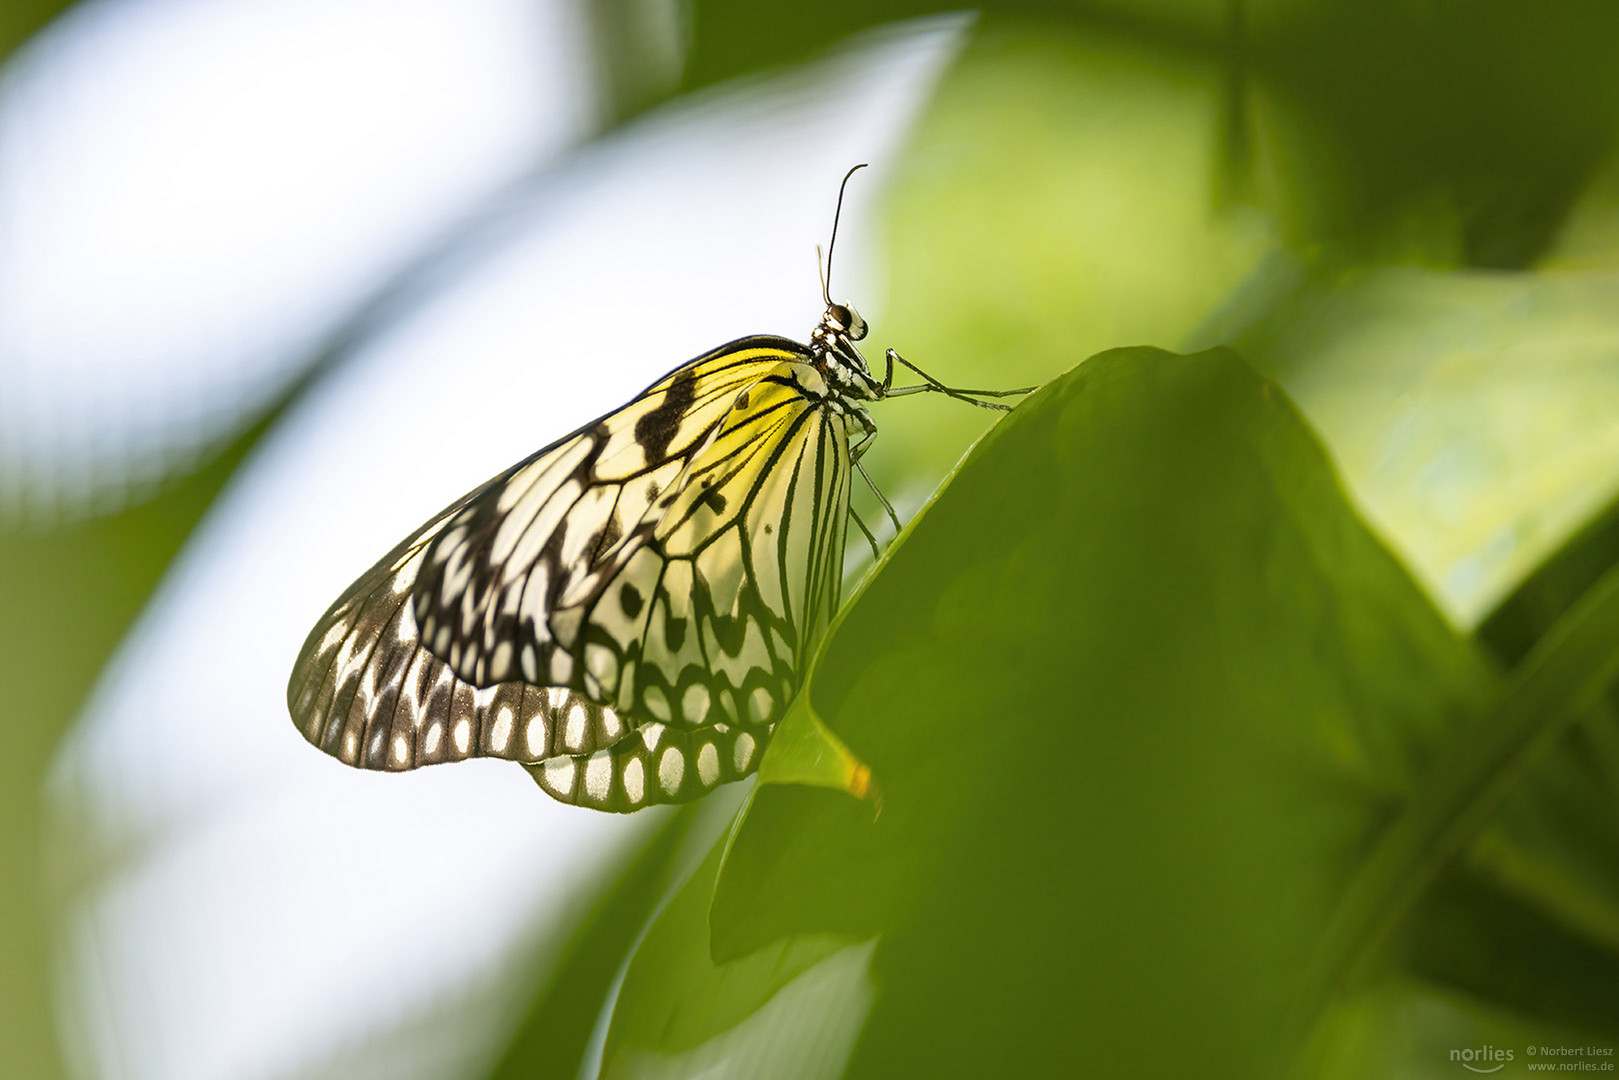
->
[[9, 0, 1619, 1080]]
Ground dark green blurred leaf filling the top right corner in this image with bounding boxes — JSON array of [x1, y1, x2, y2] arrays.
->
[[1245, 0, 1619, 269]]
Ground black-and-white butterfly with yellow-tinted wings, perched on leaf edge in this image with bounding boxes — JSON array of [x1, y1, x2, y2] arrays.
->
[[287, 165, 1028, 813]]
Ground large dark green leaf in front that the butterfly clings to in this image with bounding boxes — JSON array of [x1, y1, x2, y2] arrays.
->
[[709, 350, 1491, 1077]]
